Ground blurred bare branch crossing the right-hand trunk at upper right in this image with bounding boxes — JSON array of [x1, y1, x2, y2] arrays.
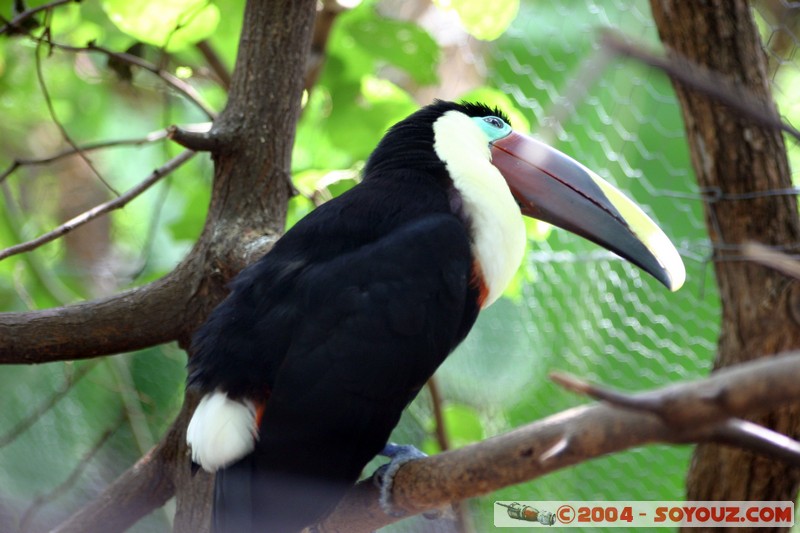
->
[[600, 30, 800, 140]]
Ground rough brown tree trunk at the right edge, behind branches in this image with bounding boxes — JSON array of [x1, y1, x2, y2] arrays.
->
[[651, 0, 800, 516]]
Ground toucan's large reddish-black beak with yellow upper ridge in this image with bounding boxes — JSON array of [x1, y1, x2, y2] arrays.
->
[[491, 131, 686, 291]]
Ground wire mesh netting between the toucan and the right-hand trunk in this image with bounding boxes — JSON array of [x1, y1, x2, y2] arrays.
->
[[384, 0, 800, 531]]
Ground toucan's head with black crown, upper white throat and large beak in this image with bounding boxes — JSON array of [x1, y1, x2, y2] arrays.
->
[[364, 101, 685, 290]]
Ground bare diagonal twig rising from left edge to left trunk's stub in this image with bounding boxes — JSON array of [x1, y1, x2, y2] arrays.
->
[[0, 150, 196, 260]]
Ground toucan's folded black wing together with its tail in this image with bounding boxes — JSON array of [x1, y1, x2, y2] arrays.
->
[[209, 214, 478, 531]]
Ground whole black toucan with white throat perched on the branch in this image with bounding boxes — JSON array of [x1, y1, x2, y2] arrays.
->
[[186, 101, 685, 533]]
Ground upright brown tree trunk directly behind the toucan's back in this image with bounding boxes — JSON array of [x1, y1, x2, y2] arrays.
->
[[174, 0, 315, 533]]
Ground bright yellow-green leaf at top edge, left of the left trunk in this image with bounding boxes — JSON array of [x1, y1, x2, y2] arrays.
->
[[102, 0, 220, 52]]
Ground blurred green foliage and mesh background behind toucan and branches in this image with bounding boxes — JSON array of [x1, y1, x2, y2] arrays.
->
[[0, 0, 800, 532]]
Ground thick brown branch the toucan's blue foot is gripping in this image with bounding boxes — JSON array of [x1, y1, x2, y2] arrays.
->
[[319, 352, 800, 533]]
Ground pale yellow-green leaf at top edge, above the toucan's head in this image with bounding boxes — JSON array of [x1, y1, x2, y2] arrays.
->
[[433, 0, 519, 41]]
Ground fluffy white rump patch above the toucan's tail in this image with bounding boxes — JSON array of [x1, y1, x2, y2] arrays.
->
[[186, 390, 258, 472]]
